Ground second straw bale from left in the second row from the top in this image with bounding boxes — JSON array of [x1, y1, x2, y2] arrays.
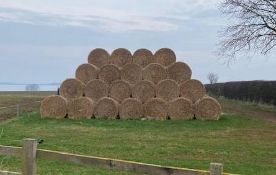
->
[[99, 64, 121, 84]]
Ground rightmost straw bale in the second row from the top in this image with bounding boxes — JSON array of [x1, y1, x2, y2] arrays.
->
[[167, 62, 192, 83]]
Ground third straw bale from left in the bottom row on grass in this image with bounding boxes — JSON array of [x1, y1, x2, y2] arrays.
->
[[94, 97, 118, 119]]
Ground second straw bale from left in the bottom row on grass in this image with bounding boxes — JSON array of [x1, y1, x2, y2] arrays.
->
[[67, 97, 94, 119]]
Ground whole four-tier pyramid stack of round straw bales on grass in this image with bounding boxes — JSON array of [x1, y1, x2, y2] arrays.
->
[[41, 48, 221, 120]]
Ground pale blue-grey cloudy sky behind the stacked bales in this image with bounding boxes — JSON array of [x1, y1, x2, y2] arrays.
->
[[0, 0, 276, 89]]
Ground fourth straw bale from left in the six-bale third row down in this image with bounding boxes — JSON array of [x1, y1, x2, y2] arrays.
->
[[132, 80, 155, 103]]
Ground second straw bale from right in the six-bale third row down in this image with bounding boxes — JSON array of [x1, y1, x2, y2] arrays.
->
[[156, 79, 179, 101]]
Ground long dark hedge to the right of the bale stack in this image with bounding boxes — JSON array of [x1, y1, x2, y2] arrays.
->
[[205, 81, 276, 105]]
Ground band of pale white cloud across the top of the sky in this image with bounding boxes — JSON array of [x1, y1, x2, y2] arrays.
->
[[0, 0, 220, 32]]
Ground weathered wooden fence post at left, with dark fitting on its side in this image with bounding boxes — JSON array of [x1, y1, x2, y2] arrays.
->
[[22, 139, 37, 175]]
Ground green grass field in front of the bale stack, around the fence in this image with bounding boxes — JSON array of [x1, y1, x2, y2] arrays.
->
[[0, 113, 276, 175]]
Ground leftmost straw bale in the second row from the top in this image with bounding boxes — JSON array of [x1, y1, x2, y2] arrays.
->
[[76, 64, 98, 84]]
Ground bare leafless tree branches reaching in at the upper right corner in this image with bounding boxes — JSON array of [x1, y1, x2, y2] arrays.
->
[[219, 0, 276, 60]]
